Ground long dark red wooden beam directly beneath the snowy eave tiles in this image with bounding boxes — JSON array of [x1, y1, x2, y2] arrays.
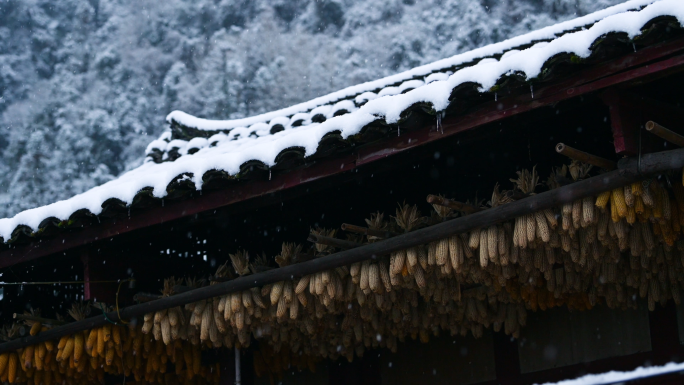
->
[[0, 38, 684, 268]]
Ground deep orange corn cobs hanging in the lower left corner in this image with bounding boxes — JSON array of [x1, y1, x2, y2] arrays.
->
[[0, 304, 220, 385]]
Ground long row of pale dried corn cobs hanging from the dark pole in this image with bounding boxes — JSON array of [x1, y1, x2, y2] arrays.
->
[[6, 162, 684, 380]]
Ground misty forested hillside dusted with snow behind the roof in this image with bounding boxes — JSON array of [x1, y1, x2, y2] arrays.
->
[[0, 0, 632, 217]]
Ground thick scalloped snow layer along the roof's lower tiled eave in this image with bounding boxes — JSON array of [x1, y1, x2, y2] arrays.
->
[[0, 0, 684, 241]]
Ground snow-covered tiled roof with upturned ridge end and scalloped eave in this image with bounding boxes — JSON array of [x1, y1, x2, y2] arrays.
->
[[0, 0, 684, 242]]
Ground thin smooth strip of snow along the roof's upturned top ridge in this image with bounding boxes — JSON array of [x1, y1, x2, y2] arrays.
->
[[166, 0, 668, 131]]
